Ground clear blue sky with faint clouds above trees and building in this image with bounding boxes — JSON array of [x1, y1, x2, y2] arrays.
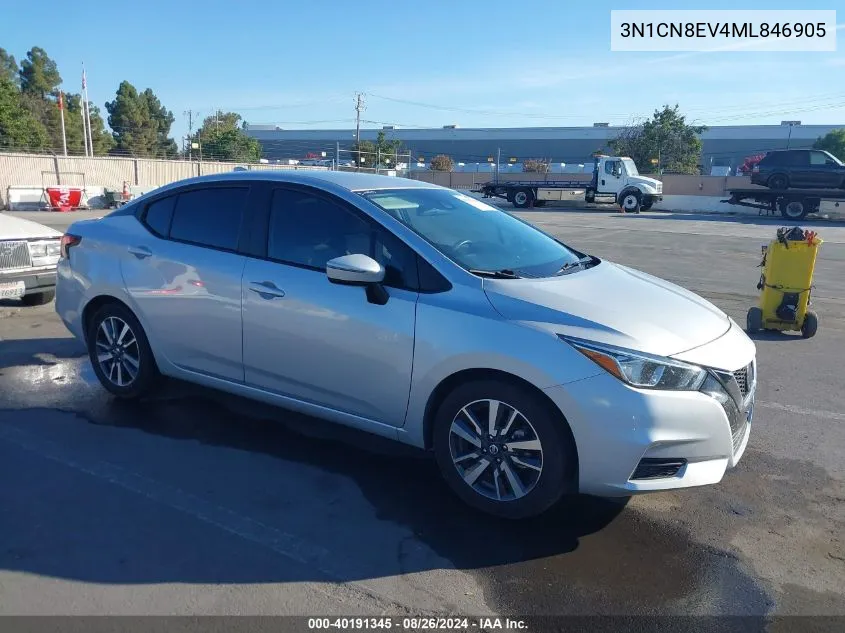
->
[[0, 0, 845, 139]]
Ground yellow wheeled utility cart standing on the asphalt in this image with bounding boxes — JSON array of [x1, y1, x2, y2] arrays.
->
[[747, 226, 822, 338]]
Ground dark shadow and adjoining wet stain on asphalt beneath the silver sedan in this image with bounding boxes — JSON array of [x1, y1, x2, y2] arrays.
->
[[0, 341, 770, 614]]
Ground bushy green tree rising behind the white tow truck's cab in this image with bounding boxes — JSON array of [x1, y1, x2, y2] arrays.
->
[[609, 105, 707, 174]]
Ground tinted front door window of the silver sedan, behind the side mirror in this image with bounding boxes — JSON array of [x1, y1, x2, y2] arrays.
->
[[267, 189, 418, 289]]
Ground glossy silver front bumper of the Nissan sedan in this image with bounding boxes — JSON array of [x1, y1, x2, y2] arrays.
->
[[546, 360, 756, 497]]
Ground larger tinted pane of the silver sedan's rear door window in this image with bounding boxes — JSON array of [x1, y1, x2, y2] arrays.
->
[[170, 187, 249, 250]]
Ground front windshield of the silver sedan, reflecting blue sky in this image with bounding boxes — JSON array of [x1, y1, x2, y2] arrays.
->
[[362, 189, 583, 277]]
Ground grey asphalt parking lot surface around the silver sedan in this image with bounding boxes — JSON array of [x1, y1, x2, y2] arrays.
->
[[0, 210, 845, 622]]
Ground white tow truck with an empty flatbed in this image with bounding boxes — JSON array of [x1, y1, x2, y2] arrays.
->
[[472, 155, 663, 213]]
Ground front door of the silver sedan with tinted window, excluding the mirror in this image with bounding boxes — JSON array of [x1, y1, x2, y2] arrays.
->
[[243, 188, 418, 426]]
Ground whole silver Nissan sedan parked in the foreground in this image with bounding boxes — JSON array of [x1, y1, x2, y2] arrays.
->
[[56, 171, 757, 518]]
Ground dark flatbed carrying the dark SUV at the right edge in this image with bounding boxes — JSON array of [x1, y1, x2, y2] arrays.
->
[[722, 187, 845, 221]]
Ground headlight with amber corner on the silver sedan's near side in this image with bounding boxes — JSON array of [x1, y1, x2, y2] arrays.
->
[[558, 335, 707, 391]]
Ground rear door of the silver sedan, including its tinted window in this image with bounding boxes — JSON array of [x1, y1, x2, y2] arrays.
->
[[122, 181, 252, 382]]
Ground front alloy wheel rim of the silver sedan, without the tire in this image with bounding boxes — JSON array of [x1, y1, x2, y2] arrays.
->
[[449, 400, 543, 501]]
